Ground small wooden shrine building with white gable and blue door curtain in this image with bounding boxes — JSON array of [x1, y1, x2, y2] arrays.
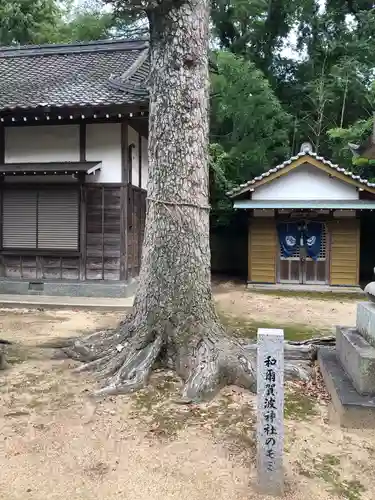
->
[[228, 144, 375, 287]]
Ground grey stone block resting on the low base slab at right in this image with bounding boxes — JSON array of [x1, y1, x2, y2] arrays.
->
[[336, 326, 375, 395]]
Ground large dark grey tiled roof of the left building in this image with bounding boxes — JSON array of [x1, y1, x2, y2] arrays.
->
[[0, 40, 149, 112]]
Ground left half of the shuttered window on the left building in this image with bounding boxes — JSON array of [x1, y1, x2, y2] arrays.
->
[[3, 189, 37, 248]]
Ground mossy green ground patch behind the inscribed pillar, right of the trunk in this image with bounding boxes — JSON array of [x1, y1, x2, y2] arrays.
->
[[219, 311, 324, 340]]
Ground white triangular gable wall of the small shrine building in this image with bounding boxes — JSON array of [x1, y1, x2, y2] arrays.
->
[[252, 164, 359, 200]]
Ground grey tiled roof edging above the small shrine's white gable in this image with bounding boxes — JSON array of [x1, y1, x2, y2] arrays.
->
[[227, 150, 375, 197]]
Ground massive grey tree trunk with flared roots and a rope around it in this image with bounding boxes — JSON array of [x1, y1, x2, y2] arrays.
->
[[69, 0, 254, 400]]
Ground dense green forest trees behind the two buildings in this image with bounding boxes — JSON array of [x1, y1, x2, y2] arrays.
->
[[0, 0, 375, 228]]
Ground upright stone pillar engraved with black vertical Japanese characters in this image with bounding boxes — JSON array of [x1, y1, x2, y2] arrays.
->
[[257, 328, 284, 496]]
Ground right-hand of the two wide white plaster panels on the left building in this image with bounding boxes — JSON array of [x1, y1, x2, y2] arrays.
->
[[86, 123, 122, 183]]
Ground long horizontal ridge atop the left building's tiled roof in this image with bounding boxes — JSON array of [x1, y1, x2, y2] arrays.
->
[[0, 38, 149, 58]]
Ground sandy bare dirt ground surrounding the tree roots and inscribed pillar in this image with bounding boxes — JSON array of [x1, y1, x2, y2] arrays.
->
[[0, 290, 375, 500]]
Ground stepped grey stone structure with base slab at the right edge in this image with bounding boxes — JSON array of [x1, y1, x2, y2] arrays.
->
[[318, 282, 375, 428]]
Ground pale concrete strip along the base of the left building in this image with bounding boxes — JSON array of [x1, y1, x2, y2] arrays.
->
[[0, 294, 134, 311]]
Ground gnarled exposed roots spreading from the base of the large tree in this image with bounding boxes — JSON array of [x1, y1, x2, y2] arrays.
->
[[64, 320, 311, 402]]
